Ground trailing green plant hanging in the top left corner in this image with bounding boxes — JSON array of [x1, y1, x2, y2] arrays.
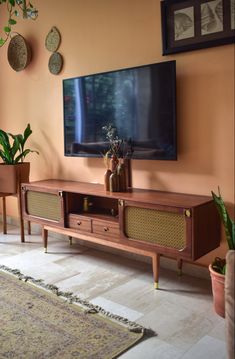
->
[[0, 0, 38, 47]]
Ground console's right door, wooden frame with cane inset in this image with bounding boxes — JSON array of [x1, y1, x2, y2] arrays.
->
[[119, 201, 192, 258]]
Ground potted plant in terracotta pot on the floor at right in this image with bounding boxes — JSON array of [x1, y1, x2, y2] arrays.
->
[[209, 188, 235, 317]]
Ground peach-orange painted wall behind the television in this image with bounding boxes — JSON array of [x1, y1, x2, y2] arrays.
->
[[0, 0, 234, 265]]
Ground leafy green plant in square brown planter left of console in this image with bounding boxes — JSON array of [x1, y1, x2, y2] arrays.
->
[[0, 124, 38, 194]]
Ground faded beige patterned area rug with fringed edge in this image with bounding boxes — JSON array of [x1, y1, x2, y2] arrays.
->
[[0, 266, 155, 359]]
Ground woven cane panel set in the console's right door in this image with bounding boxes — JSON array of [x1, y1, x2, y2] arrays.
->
[[125, 207, 186, 250]]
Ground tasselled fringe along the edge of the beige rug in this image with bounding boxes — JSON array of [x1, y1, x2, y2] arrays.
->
[[0, 264, 157, 337]]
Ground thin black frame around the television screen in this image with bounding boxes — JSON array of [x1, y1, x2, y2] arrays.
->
[[62, 60, 178, 161]]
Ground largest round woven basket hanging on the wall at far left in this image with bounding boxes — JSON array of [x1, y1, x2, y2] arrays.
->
[[7, 34, 31, 71]]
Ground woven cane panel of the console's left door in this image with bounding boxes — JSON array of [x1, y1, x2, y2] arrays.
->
[[27, 191, 61, 221]]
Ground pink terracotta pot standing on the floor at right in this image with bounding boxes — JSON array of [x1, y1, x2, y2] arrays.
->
[[209, 264, 225, 318]]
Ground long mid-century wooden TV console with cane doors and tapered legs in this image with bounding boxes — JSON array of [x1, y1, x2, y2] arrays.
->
[[21, 180, 220, 288]]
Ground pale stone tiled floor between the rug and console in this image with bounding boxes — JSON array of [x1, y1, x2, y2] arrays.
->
[[0, 227, 226, 359]]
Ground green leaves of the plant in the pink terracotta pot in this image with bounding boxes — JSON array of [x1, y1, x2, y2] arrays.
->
[[211, 188, 235, 274]]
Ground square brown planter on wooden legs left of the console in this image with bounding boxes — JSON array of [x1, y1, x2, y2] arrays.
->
[[0, 162, 30, 194]]
